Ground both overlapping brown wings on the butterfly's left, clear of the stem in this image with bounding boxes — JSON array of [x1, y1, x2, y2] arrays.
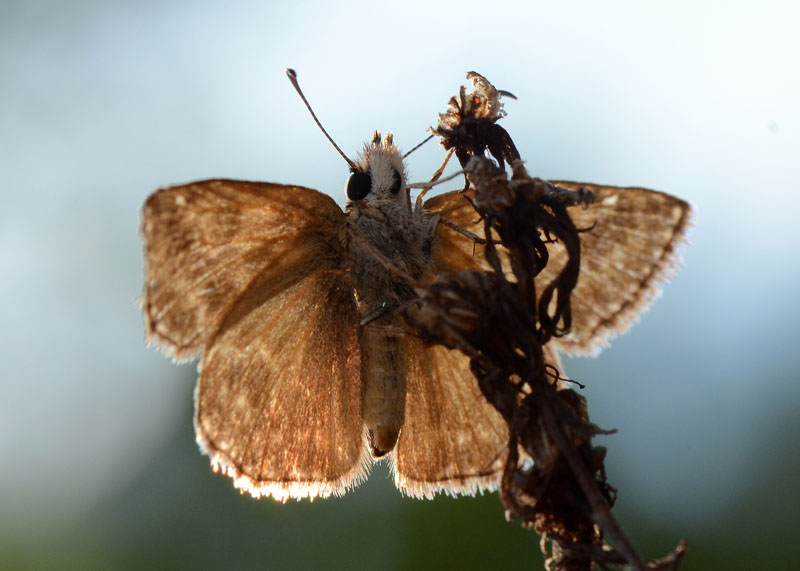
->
[[142, 180, 366, 499]]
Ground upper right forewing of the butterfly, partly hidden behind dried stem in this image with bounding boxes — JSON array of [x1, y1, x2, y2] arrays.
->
[[425, 182, 691, 354]]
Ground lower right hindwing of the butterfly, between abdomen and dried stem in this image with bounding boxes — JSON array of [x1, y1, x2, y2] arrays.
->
[[394, 209, 558, 498]]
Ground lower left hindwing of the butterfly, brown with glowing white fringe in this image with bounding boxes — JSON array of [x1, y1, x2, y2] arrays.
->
[[195, 270, 368, 500]]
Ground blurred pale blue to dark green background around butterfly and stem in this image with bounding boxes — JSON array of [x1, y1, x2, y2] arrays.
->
[[0, 0, 800, 569]]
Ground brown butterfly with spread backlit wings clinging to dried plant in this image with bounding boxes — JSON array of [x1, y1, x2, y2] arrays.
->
[[142, 70, 690, 501]]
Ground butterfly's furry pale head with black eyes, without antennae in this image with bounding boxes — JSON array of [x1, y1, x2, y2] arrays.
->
[[345, 131, 408, 203]]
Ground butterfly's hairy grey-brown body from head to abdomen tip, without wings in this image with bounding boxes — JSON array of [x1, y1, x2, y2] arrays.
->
[[345, 133, 438, 458]]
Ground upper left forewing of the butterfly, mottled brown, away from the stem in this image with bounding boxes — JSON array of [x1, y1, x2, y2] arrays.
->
[[142, 180, 344, 360]]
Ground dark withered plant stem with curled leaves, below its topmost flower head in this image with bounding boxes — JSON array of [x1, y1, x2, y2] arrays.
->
[[406, 157, 686, 571]]
